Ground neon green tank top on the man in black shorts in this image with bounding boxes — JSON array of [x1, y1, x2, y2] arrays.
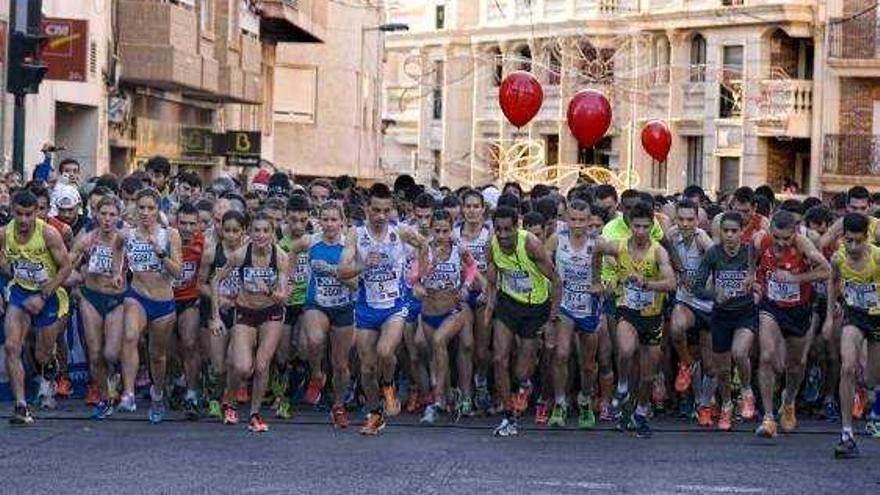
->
[[492, 229, 550, 305]]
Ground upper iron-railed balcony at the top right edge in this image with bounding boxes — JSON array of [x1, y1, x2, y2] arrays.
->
[[828, 15, 880, 77]]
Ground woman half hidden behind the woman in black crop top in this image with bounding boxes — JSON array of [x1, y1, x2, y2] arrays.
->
[[199, 211, 247, 418]]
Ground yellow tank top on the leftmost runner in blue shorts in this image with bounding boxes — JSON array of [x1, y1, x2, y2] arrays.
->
[[4, 218, 68, 316]]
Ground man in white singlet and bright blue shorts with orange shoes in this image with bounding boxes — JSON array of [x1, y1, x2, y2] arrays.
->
[[337, 183, 426, 435]]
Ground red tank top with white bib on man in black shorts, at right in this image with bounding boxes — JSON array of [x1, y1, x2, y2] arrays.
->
[[755, 234, 813, 308]]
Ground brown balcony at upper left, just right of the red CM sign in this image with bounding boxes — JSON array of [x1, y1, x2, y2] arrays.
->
[[117, 0, 202, 91]]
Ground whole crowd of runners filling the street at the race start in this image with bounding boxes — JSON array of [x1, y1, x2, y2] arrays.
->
[[0, 157, 880, 457]]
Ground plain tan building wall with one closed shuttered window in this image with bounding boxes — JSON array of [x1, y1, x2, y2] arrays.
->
[[265, 2, 385, 179]]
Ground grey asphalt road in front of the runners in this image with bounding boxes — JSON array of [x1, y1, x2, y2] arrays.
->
[[0, 405, 880, 495]]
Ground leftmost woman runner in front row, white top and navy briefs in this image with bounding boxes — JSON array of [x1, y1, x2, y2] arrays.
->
[[70, 196, 127, 419]]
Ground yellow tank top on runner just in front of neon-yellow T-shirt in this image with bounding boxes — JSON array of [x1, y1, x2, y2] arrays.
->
[[617, 239, 666, 317]]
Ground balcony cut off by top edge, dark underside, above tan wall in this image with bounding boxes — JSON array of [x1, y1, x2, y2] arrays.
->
[[258, 0, 328, 43]]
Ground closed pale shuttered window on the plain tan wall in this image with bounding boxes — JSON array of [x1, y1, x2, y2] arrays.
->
[[272, 66, 318, 124]]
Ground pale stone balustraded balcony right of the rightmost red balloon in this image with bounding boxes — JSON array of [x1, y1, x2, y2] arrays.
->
[[751, 79, 813, 138]]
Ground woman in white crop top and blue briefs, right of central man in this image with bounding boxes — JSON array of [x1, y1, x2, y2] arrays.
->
[[413, 209, 477, 425]]
